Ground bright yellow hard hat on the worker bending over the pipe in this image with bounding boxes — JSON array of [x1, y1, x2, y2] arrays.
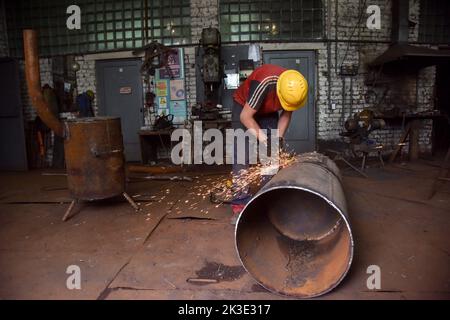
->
[[277, 70, 308, 111]]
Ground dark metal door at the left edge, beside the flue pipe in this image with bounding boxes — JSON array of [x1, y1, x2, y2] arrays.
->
[[0, 58, 28, 170]]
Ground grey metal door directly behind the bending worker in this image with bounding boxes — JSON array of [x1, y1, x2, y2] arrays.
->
[[263, 51, 316, 153]]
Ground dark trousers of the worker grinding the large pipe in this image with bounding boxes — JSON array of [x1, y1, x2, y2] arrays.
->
[[231, 101, 279, 204]]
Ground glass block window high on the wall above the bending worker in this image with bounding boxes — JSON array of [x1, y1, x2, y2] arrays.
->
[[219, 0, 324, 42]]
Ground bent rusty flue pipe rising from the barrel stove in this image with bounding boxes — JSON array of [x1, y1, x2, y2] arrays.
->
[[23, 29, 64, 137]]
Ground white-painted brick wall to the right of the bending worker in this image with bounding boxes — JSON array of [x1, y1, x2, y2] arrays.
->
[[316, 0, 435, 151]]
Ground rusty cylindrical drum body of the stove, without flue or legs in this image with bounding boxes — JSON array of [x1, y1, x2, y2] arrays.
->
[[64, 117, 125, 200]]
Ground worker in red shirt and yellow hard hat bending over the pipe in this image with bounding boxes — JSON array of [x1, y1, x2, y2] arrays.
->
[[231, 64, 308, 224]]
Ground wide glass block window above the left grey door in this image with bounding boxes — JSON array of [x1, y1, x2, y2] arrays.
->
[[5, 0, 191, 57]]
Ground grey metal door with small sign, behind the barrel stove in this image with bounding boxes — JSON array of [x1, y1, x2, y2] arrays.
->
[[96, 59, 143, 161]]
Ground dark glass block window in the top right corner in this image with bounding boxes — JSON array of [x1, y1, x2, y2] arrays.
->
[[419, 0, 450, 43]]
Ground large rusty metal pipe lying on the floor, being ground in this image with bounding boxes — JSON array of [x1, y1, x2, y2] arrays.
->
[[235, 152, 354, 298]]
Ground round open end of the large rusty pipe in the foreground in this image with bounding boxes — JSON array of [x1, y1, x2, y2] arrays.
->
[[236, 187, 353, 298]]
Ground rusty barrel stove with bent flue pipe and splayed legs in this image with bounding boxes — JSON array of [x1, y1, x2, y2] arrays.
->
[[23, 30, 138, 220]]
